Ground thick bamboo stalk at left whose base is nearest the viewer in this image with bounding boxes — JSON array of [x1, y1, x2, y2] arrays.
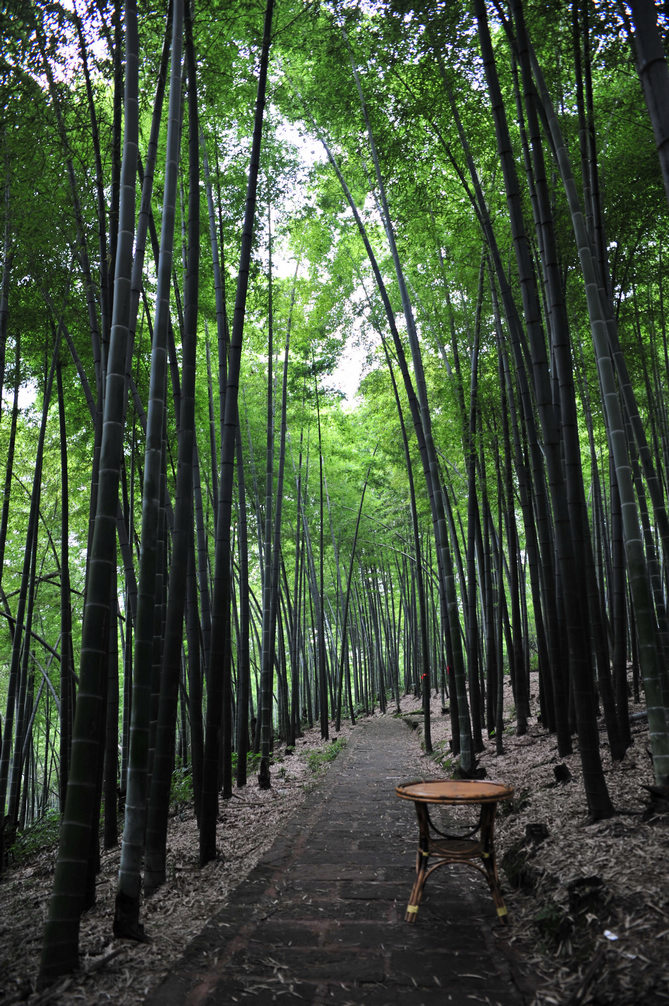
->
[[39, 0, 139, 985]]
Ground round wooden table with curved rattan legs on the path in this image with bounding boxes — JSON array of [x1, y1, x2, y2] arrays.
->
[[395, 779, 513, 923]]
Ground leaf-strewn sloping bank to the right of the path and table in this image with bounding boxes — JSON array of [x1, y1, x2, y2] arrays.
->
[[414, 680, 669, 1006]]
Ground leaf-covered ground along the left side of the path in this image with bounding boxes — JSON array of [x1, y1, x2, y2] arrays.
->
[[0, 724, 358, 1006]]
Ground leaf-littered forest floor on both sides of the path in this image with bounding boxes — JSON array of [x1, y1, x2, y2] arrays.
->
[[0, 676, 669, 1006]]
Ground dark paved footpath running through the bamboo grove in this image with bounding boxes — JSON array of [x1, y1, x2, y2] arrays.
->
[[146, 716, 530, 1006]]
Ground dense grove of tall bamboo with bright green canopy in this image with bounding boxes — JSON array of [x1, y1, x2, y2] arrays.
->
[[0, 0, 669, 1001]]
